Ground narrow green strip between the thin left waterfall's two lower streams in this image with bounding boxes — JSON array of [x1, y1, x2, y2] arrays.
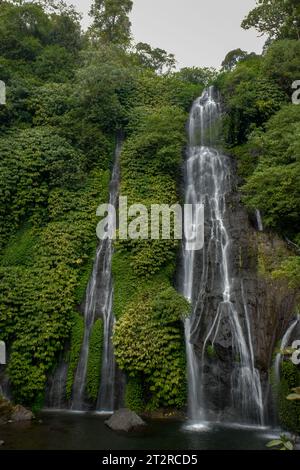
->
[[86, 319, 104, 402]]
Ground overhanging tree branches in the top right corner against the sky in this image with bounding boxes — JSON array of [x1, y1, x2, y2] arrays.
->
[[242, 0, 300, 40]]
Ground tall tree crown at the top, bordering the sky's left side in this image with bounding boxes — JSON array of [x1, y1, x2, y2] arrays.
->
[[90, 0, 133, 45]]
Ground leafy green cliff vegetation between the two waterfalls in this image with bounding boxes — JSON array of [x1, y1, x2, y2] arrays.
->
[[113, 90, 193, 409]]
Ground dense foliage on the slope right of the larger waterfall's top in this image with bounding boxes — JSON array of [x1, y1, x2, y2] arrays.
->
[[216, 36, 300, 288]]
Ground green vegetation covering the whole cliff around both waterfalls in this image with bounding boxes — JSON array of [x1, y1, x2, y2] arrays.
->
[[0, 0, 300, 422]]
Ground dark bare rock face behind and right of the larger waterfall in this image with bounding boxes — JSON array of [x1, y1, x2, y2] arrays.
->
[[179, 164, 297, 421]]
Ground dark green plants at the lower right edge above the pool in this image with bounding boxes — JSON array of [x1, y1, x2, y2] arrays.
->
[[277, 361, 300, 434]]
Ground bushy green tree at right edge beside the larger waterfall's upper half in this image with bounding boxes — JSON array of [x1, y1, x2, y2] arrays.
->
[[243, 104, 300, 243]]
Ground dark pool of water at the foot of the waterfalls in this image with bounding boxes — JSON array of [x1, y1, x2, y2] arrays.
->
[[0, 412, 276, 450]]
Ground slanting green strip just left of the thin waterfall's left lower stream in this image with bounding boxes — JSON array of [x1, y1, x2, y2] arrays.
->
[[66, 313, 84, 400]]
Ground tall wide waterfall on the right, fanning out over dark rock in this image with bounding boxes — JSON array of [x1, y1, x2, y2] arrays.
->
[[182, 87, 264, 424]]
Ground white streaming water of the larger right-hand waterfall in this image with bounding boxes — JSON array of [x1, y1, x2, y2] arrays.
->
[[183, 87, 264, 424]]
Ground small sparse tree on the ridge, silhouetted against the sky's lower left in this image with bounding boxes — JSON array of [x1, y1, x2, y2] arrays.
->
[[136, 42, 176, 73]]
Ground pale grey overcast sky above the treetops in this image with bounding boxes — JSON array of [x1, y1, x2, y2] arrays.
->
[[68, 0, 264, 67]]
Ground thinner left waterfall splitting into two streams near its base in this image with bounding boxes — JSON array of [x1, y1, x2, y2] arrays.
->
[[72, 141, 121, 412]]
